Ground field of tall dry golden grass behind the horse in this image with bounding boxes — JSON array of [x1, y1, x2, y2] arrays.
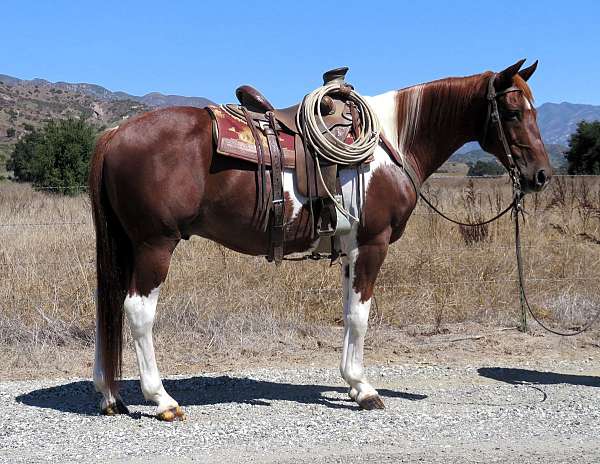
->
[[0, 178, 600, 376]]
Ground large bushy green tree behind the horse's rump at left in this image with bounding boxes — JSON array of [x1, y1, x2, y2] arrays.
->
[[7, 119, 96, 195]]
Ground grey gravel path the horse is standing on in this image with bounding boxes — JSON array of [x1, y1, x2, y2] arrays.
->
[[0, 360, 600, 464]]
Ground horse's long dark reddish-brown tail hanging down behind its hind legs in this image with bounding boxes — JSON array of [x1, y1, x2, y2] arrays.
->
[[88, 129, 131, 392]]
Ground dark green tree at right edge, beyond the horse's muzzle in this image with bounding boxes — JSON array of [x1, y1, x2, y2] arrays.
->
[[565, 121, 600, 174]]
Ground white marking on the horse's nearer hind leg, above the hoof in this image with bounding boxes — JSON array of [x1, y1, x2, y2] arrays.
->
[[123, 287, 179, 413]]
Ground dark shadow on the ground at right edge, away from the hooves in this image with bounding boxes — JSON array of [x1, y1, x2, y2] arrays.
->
[[477, 367, 600, 387]]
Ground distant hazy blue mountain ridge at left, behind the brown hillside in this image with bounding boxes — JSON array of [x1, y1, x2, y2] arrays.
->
[[0, 74, 212, 108]]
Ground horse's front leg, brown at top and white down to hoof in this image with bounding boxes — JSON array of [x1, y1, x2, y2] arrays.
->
[[340, 241, 388, 409]]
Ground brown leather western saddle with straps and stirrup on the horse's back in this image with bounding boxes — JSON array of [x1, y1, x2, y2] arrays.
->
[[209, 67, 369, 263]]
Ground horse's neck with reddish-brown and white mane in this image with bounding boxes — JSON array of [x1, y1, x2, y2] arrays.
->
[[376, 75, 487, 182]]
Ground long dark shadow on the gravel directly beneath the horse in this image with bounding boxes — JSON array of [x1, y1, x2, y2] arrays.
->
[[16, 376, 427, 415]]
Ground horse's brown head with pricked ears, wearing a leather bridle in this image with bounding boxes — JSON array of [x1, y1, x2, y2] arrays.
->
[[479, 60, 552, 192]]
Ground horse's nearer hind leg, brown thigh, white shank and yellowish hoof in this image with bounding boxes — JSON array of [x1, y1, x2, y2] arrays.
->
[[123, 239, 184, 421]]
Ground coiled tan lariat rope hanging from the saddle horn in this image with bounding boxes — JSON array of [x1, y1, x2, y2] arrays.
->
[[296, 83, 381, 222]]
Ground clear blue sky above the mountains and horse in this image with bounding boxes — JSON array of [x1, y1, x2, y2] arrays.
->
[[0, 0, 600, 105]]
